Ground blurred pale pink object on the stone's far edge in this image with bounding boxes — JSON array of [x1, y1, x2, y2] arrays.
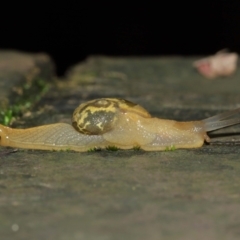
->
[[193, 50, 238, 79]]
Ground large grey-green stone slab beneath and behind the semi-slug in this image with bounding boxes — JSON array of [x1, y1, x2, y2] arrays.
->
[[0, 54, 240, 240]]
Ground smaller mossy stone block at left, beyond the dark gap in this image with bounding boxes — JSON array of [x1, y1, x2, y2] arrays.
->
[[0, 50, 54, 107]]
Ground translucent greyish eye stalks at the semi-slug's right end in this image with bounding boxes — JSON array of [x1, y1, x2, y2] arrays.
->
[[203, 108, 240, 132]]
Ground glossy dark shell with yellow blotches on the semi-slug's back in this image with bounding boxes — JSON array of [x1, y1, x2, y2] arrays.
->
[[72, 98, 151, 135]]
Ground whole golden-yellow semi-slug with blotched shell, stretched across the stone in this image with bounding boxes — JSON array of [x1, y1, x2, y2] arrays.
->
[[0, 98, 240, 152]]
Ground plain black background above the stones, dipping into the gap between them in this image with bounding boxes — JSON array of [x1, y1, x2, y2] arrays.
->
[[0, 0, 240, 75]]
